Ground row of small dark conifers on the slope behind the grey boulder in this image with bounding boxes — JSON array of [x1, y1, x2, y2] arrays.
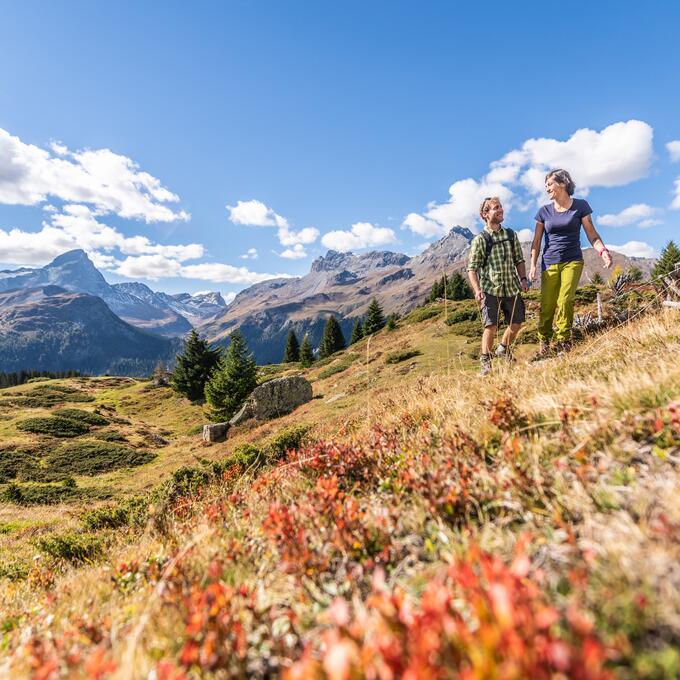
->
[[283, 298, 397, 368]]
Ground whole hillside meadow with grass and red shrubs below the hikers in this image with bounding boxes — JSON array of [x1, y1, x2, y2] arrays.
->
[[0, 292, 680, 680]]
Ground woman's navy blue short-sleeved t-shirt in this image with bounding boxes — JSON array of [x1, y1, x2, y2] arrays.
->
[[535, 198, 593, 269]]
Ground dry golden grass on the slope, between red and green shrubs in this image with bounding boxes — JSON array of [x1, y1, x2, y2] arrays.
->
[[0, 310, 680, 680]]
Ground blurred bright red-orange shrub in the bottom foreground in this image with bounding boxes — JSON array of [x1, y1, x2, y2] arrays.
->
[[284, 549, 613, 680]]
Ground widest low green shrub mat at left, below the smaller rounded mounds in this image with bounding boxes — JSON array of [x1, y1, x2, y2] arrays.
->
[[46, 441, 155, 476]]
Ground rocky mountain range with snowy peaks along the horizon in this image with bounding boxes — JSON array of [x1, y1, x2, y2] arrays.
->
[[0, 227, 653, 374]]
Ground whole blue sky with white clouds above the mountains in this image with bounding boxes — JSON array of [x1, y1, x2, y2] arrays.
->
[[0, 1, 680, 294]]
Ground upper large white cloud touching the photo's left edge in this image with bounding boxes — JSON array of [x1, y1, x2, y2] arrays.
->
[[0, 128, 189, 222]]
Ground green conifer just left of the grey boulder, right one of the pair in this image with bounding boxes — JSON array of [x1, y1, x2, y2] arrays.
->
[[205, 329, 257, 422]]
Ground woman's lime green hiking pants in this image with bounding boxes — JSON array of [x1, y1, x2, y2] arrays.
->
[[538, 260, 583, 342]]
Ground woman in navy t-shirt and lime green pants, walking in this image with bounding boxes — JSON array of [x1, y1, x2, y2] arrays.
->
[[529, 170, 612, 360]]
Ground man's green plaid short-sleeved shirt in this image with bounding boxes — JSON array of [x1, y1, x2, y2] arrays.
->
[[468, 227, 524, 297]]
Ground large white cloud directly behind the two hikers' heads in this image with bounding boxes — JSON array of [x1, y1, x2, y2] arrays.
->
[[403, 120, 652, 237]]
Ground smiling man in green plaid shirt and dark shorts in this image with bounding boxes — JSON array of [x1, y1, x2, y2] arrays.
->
[[468, 196, 529, 376]]
